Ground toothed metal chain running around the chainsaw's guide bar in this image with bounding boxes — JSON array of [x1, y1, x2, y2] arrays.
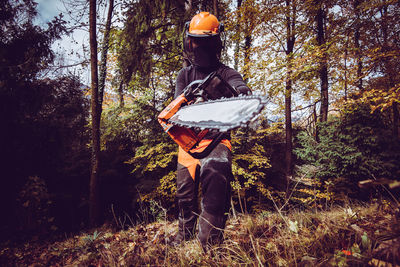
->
[[169, 94, 267, 132]]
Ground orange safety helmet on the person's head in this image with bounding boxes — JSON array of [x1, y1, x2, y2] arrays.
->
[[186, 12, 224, 37]]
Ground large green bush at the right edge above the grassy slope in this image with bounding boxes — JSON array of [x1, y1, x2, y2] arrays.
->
[[294, 104, 400, 200]]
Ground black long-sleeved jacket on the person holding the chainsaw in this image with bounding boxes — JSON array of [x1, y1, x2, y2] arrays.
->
[[175, 63, 251, 140]]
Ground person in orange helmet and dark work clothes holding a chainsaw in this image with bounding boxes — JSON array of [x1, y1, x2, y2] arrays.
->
[[173, 12, 251, 249]]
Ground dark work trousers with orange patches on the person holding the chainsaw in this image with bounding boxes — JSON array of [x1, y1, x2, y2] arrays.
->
[[176, 140, 233, 249]]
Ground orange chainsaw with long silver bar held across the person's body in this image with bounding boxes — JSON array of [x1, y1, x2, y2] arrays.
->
[[158, 72, 266, 159]]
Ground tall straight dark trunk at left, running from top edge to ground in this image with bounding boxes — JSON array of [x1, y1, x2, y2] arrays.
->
[[89, 0, 100, 226]]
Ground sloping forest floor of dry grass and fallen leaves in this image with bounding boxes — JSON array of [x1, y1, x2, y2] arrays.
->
[[0, 202, 400, 266]]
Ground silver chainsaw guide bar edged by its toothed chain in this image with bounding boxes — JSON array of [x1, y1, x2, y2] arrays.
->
[[168, 94, 267, 132]]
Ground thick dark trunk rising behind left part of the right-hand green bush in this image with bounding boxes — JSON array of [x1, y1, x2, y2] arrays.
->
[[316, 1, 329, 121]]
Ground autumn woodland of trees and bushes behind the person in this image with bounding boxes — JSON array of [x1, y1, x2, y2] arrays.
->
[[0, 0, 400, 247]]
